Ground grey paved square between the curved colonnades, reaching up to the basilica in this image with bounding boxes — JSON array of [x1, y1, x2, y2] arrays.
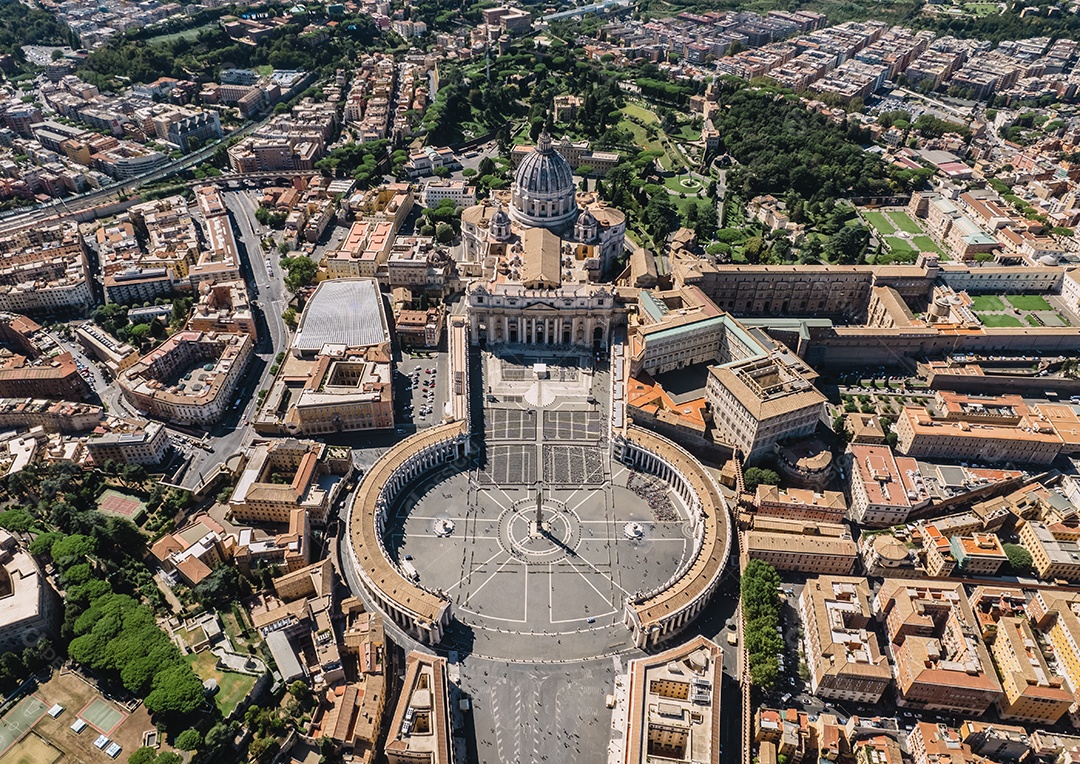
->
[[386, 352, 693, 660]]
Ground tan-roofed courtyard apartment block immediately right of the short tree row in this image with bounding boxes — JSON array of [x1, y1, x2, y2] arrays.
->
[[799, 576, 892, 703]]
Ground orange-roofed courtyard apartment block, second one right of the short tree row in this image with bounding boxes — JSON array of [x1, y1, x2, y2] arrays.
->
[[874, 578, 1001, 716]]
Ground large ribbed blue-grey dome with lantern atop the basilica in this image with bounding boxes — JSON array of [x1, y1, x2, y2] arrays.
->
[[510, 132, 578, 228]]
